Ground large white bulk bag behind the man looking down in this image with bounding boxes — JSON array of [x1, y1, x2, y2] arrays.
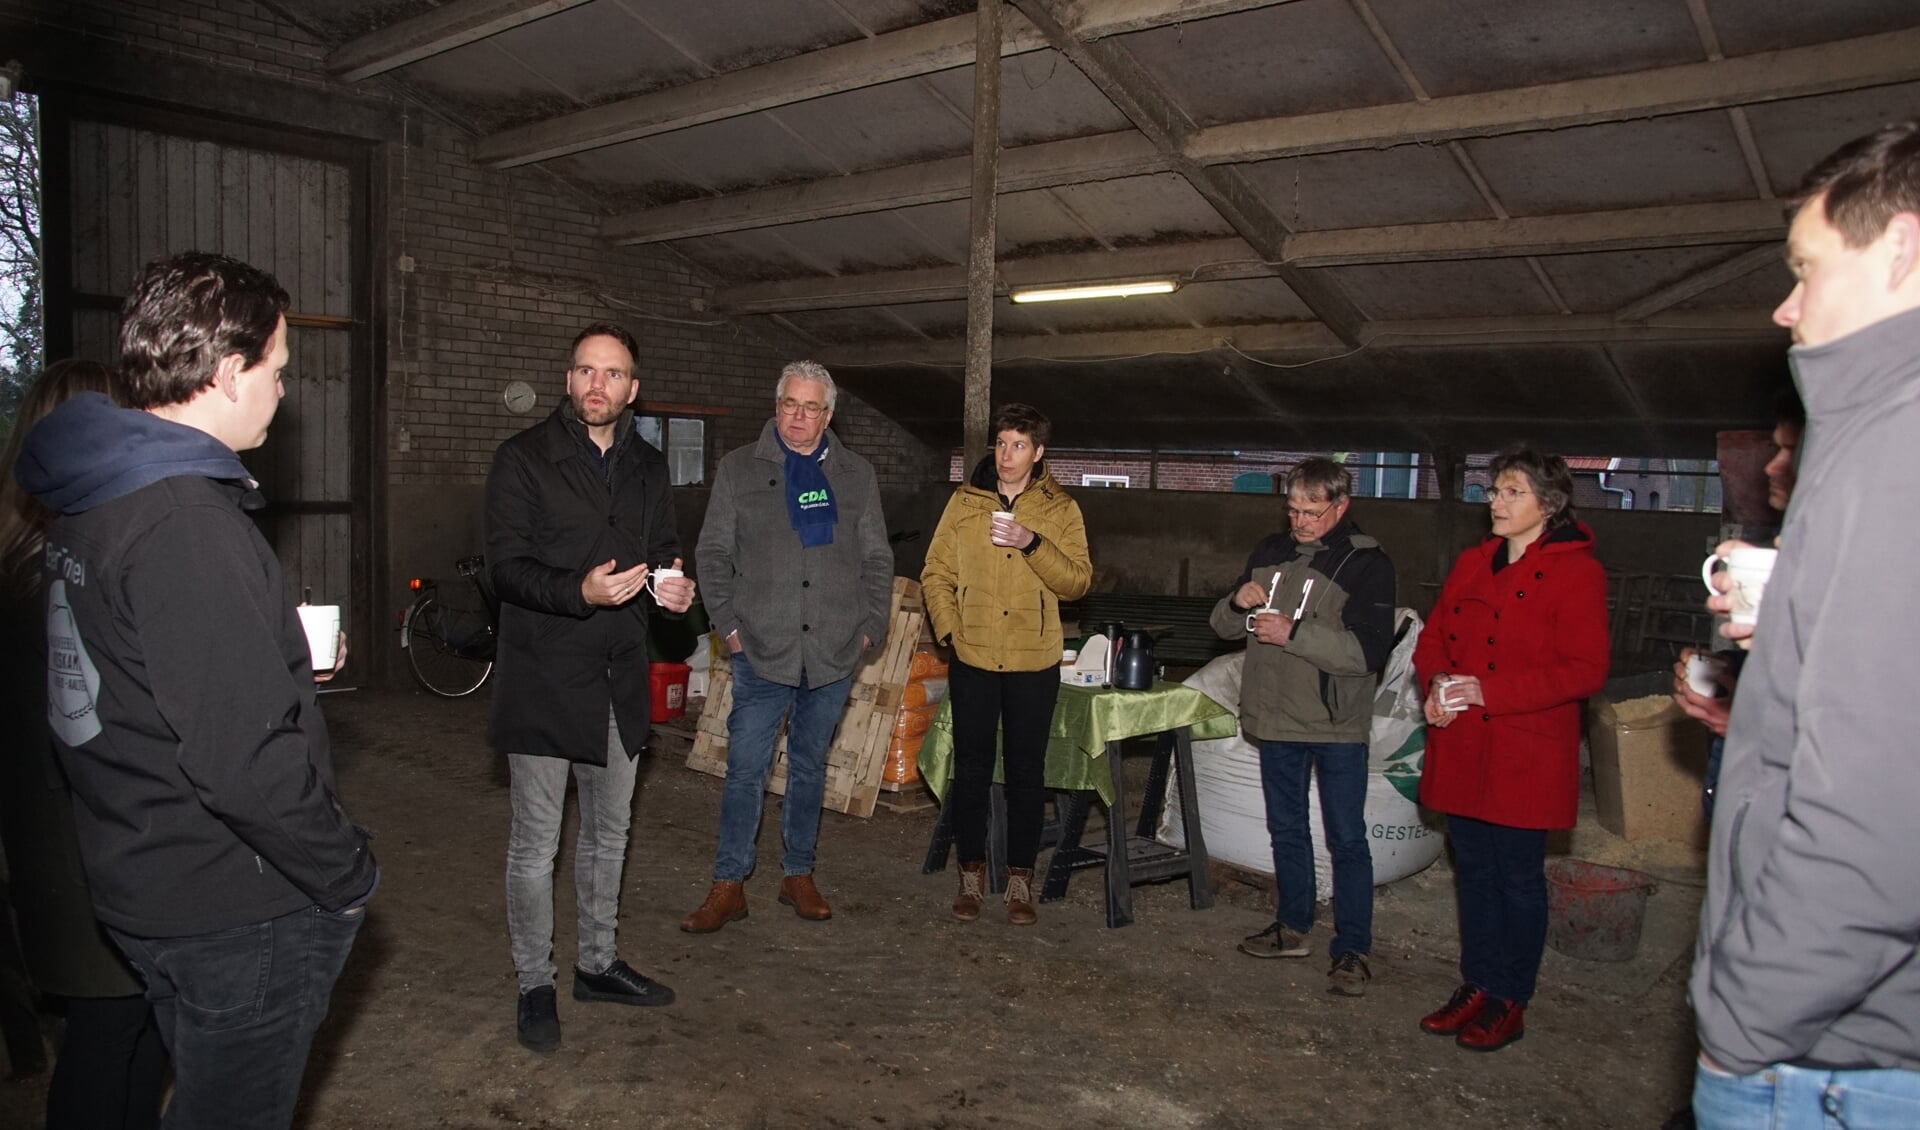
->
[[1158, 608, 1442, 902]]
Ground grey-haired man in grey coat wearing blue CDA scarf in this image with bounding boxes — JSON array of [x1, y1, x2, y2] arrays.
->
[[680, 361, 893, 934]]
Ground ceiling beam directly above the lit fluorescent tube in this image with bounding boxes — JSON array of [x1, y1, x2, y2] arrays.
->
[[714, 200, 1786, 312]]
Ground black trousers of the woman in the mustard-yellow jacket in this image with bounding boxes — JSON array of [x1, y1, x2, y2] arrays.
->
[[947, 658, 1060, 867]]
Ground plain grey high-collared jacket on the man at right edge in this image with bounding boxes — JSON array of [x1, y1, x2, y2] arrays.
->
[[1692, 301, 1920, 1074]]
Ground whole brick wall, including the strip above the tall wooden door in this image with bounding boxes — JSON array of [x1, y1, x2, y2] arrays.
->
[[0, 0, 941, 489]]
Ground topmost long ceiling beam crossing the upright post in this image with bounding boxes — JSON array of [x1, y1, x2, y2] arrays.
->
[[474, 0, 1290, 169]]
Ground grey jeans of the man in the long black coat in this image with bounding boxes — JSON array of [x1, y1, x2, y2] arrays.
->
[[507, 712, 639, 992]]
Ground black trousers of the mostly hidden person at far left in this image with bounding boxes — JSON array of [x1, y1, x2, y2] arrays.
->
[[46, 996, 167, 1130]]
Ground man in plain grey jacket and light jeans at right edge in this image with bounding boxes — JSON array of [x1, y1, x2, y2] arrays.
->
[[1692, 121, 1920, 1130]]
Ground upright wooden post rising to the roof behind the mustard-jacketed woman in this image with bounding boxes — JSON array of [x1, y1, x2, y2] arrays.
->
[[960, 0, 1000, 476]]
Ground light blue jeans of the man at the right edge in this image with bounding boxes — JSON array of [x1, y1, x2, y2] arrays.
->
[[1693, 1063, 1920, 1130]]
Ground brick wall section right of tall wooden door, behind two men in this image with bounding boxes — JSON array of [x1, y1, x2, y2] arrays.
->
[[388, 117, 939, 487]]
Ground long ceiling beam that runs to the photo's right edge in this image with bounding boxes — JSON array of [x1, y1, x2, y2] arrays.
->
[[601, 31, 1920, 244]]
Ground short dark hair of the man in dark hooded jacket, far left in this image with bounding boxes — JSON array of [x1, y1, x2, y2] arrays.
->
[[119, 251, 290, 409]]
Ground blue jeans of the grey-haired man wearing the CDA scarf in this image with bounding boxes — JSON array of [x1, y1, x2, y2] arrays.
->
[[714, 652, 852, 883]]
